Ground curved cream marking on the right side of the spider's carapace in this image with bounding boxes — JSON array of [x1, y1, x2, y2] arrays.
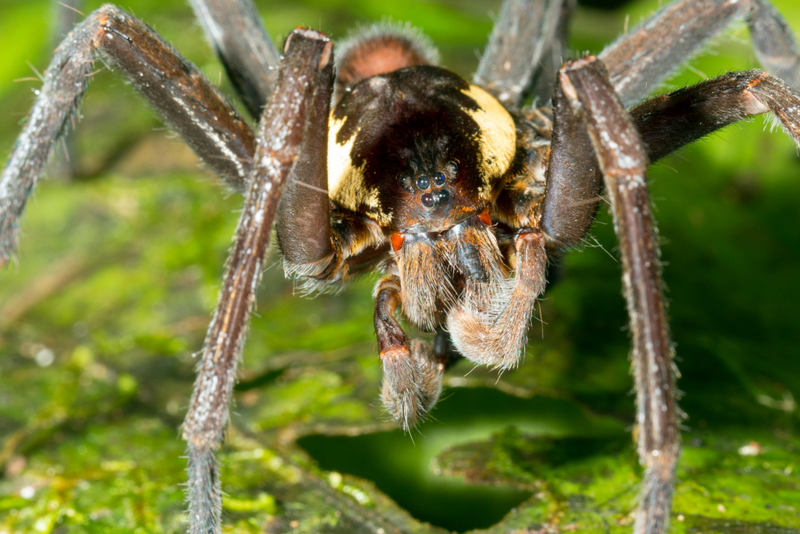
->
[[464, 85, 517, 200]]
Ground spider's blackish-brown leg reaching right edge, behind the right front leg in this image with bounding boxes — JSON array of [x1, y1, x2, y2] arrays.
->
[[630, 70, 800, 161]]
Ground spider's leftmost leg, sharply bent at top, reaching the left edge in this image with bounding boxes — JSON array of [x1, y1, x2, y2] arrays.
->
[[0, 5, 255, 265]]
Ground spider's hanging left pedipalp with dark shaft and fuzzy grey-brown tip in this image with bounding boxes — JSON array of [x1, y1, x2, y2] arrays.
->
[[374, 274, 445, 432]]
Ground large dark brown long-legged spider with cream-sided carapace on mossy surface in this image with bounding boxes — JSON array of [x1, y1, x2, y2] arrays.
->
[[0, 0, 800, 532]]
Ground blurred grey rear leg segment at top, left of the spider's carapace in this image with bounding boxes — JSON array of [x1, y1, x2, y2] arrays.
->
[[190, 0, 280, 118]]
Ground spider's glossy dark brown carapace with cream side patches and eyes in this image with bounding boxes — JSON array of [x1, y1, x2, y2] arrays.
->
[[328, 66, 516, 233]]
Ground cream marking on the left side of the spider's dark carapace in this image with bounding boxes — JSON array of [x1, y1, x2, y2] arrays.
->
[[328, 114, 392, 225]]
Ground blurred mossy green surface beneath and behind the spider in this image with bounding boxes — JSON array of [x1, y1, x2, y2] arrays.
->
[[0, 0, 800, 534]]
